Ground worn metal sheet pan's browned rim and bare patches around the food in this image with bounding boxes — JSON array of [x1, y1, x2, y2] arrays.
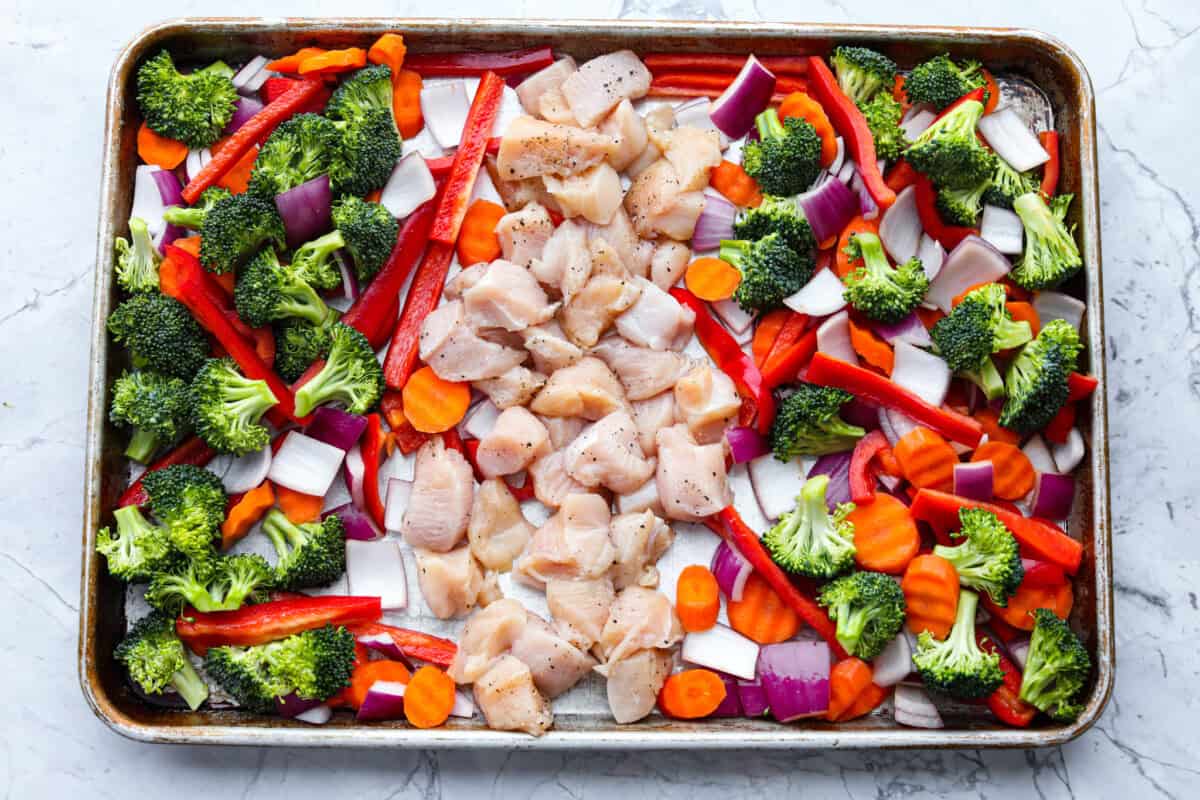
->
[[79, 18, 1115, 748]]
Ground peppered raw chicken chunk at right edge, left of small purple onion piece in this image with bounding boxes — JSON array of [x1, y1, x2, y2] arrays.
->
[[654, 425, 733, 522]]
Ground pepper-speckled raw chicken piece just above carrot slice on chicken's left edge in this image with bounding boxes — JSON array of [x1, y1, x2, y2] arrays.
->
[[420, 300, 526, 381]]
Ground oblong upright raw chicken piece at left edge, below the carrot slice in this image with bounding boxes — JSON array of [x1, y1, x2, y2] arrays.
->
[[400, 437, 475, 553]]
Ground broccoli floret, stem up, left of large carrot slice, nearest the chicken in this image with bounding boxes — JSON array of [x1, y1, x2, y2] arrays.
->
[[762, 475, 854, 578]]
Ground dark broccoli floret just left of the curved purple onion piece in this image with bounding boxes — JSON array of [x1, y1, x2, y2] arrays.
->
[[200, 192, 287, 272]]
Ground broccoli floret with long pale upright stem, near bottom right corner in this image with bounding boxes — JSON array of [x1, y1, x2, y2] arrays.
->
[[912, 589, 1004, 700]]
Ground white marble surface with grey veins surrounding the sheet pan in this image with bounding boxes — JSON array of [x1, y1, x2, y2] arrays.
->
[[0, 0, 1200, 800]]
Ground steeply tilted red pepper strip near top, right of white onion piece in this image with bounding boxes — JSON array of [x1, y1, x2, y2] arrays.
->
[[430, 72, 504, 245]]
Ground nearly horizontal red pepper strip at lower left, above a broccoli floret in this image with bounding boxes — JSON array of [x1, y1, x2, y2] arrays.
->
[[175, 595, 383, 656]]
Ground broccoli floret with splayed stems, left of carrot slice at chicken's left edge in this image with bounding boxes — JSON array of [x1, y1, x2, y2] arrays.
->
[[296, 323, 383, 416]]
